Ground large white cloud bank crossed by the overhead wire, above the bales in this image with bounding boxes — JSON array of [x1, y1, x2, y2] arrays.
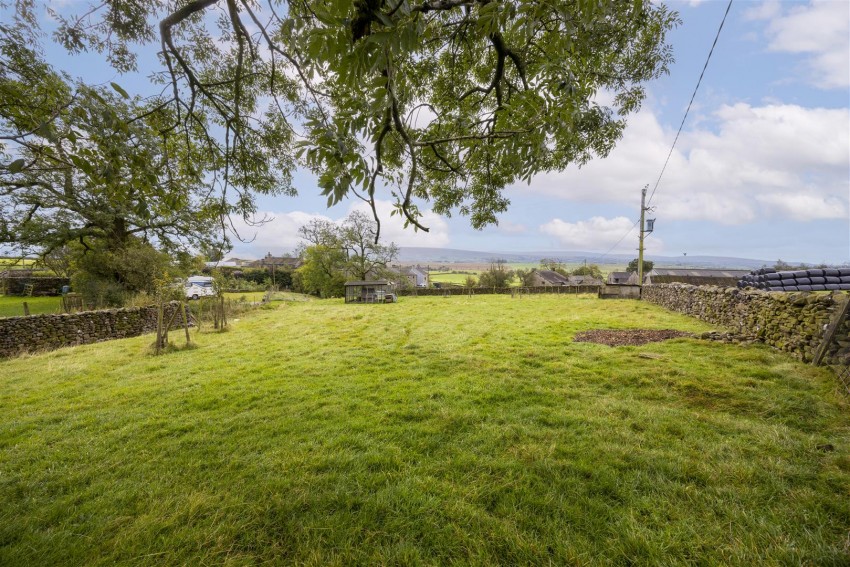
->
[[517, 103, 850, 224]]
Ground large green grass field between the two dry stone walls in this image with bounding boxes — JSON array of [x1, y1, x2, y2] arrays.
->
[[0, 296, 850, 565]]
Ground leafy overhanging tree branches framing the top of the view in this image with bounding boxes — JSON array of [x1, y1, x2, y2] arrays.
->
[[0, 0, 678, 240]]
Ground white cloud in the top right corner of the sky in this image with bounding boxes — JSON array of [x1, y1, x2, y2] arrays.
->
[[748, 0, 850, 89]]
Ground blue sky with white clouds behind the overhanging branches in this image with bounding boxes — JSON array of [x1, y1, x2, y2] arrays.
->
[[26, 0, 850, 263]]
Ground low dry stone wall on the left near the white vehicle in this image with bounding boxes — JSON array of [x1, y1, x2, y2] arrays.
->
[[0, 302, 191, 357]]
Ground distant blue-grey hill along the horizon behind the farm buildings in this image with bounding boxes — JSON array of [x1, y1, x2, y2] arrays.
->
[[399, 247, 780, 270]]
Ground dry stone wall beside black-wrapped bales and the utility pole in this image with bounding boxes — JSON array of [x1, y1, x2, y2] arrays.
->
[[643, 284, 850, 363]]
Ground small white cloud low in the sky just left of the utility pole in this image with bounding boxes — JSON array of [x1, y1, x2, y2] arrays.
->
[[540, 217, 662, 254]]
